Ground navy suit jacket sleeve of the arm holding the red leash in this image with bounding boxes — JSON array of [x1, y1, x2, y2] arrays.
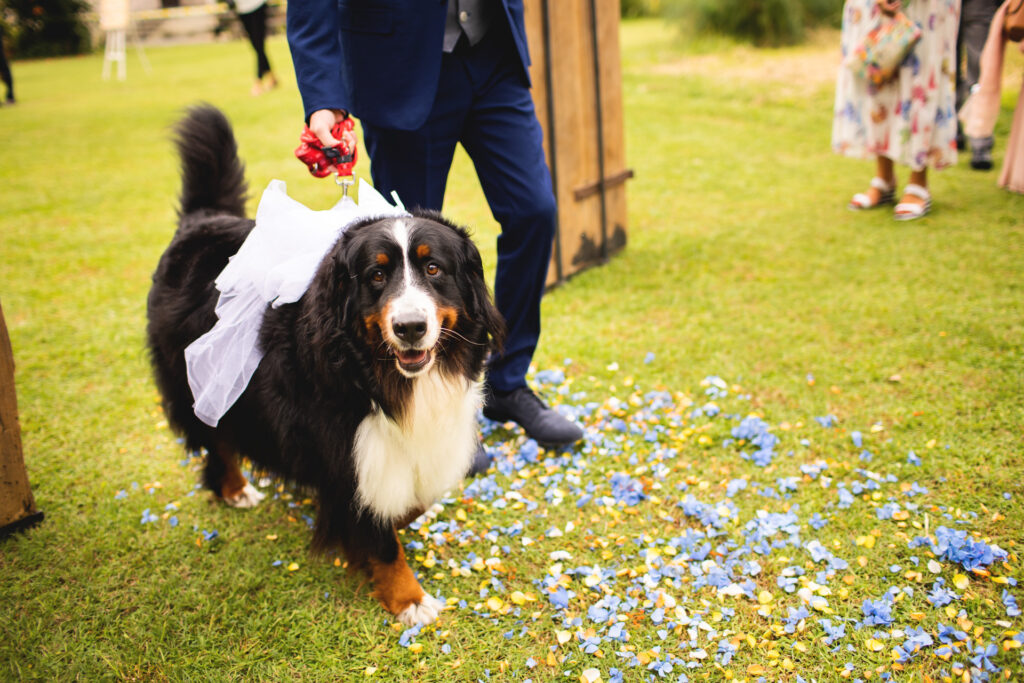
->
[[287, 0, 351, 122]]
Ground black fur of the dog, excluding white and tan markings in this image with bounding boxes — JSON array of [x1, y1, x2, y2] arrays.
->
[[147, 111, 504, 614]]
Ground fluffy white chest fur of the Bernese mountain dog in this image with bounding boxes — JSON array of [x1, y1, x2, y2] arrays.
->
[[355, 370, 481, 519]]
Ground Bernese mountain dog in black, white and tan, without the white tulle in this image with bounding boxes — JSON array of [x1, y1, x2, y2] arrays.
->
[[147, 105, 504, 626]]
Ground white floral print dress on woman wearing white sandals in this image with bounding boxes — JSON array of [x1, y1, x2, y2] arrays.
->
[[833, 0, 961, 171]]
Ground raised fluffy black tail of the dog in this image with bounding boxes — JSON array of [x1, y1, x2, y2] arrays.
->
[[174, 104, 249, 217]]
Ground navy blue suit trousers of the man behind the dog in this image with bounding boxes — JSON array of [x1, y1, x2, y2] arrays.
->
[[362, 25, 556, 391]]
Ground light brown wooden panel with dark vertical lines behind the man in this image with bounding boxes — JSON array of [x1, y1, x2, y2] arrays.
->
[[525, 0, 633, 285]]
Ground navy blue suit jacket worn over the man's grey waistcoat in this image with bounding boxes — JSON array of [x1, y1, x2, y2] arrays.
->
[[288, 0, 529, 130]]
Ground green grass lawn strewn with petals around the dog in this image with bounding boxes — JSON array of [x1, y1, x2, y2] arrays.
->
[[0, 22, 1024, 683]]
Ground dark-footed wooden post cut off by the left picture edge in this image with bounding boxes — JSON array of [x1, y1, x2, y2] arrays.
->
[[0, 299, 43, 538]]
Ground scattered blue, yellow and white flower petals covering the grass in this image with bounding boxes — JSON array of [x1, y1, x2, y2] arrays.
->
[[114, 368, 1024, 683]]
